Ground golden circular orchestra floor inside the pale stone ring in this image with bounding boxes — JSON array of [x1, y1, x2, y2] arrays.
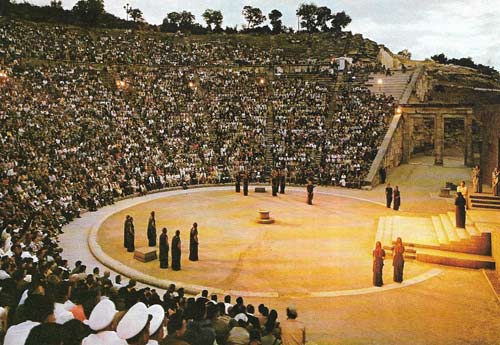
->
[[97, 188, 429, 296]]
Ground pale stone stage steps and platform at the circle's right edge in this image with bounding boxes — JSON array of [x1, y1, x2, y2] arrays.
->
[[375, 212, 496, 268]]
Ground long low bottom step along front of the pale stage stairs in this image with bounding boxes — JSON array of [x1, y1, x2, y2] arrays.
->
[[417, 248, 495, 269]]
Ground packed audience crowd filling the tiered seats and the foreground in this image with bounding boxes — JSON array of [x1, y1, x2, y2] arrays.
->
[[0, 18, 393, 345]]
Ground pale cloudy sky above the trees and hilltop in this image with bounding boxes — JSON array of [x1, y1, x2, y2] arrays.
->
[[28, 0, 500, 70]]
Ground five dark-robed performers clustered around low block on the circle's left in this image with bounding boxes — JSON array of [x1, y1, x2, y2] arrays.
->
[[123, 211, 199, 271]]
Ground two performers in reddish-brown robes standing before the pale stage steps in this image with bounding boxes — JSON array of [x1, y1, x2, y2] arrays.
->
[[373, 237, 405, 286]]
